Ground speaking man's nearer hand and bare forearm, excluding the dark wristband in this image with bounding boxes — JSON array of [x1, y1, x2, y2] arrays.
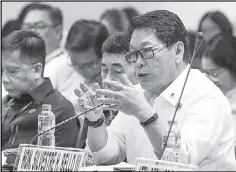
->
[[96, 76, 162, 155]]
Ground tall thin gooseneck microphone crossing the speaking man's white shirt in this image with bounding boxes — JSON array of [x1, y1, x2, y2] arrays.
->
[[159, 32, 204, 160]]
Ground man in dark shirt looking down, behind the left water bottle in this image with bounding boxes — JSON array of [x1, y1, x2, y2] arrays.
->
[[1, 30, 79, 156]]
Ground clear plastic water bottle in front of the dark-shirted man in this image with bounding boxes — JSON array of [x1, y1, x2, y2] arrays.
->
[[37, 104, 55, 146]]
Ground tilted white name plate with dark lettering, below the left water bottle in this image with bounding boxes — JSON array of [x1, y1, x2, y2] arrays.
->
[[14, 145, 86, 171]]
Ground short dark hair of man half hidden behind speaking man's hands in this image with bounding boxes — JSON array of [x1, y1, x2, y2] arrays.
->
[[102, 32, 130, 54]]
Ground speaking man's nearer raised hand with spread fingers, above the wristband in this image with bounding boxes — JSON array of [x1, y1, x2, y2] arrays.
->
[[96, 75, 153, 121]]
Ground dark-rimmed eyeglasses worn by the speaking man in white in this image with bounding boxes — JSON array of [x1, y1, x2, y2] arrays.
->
[[124, 44, 166, 63]]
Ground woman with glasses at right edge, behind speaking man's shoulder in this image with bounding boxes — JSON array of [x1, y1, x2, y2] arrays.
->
[[202, 34, 236, 157]]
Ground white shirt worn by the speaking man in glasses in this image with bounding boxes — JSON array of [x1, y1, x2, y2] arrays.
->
[[90, 68, 236, 170]]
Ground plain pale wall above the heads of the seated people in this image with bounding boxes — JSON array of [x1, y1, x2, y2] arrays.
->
[[2, 2, 236, 35]]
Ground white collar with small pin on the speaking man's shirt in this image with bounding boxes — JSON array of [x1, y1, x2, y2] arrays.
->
[[160, 65, 190, 106]]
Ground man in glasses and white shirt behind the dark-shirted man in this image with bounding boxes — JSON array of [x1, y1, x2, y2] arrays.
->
[[18, 3, 70, 92]]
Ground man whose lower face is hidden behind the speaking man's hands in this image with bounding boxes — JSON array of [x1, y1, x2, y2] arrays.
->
[[75, 32, 138, 126]]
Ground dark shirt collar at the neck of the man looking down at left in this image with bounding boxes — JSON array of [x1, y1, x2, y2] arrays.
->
[[29, 78, 53, 103]]
